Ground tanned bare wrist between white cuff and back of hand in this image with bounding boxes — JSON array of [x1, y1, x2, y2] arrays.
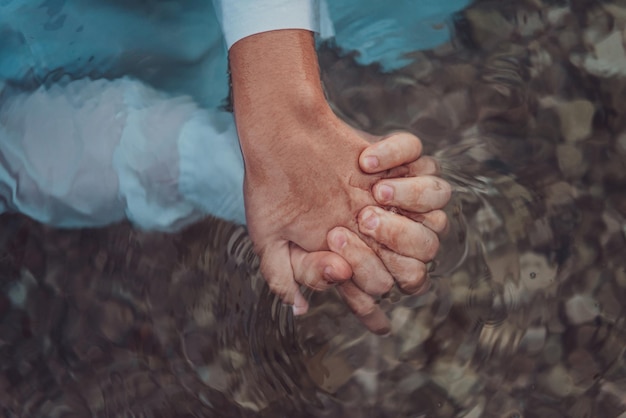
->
[[230, 29, 332, 141]]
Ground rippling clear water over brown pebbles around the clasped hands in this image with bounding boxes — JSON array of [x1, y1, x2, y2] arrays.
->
[[0, 0, 626, 418]]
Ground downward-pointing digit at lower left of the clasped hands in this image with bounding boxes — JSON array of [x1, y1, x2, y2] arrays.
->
[[260, 241, 309, 315]]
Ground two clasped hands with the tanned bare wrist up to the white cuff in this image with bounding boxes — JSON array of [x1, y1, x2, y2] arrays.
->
[[230, 30, 450, 333]]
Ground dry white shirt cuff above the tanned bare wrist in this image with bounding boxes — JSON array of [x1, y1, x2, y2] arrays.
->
[[213, 0, 321, 49]]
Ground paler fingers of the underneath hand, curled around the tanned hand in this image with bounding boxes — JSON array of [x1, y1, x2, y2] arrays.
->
[[328, 133, 451, 332]]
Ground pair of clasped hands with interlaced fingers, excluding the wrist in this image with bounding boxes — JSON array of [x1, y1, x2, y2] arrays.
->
[[239, 109, 450, 334]]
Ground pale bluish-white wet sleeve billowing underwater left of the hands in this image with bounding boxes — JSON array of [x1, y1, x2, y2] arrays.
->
[[0, 78, 245, 230]]
